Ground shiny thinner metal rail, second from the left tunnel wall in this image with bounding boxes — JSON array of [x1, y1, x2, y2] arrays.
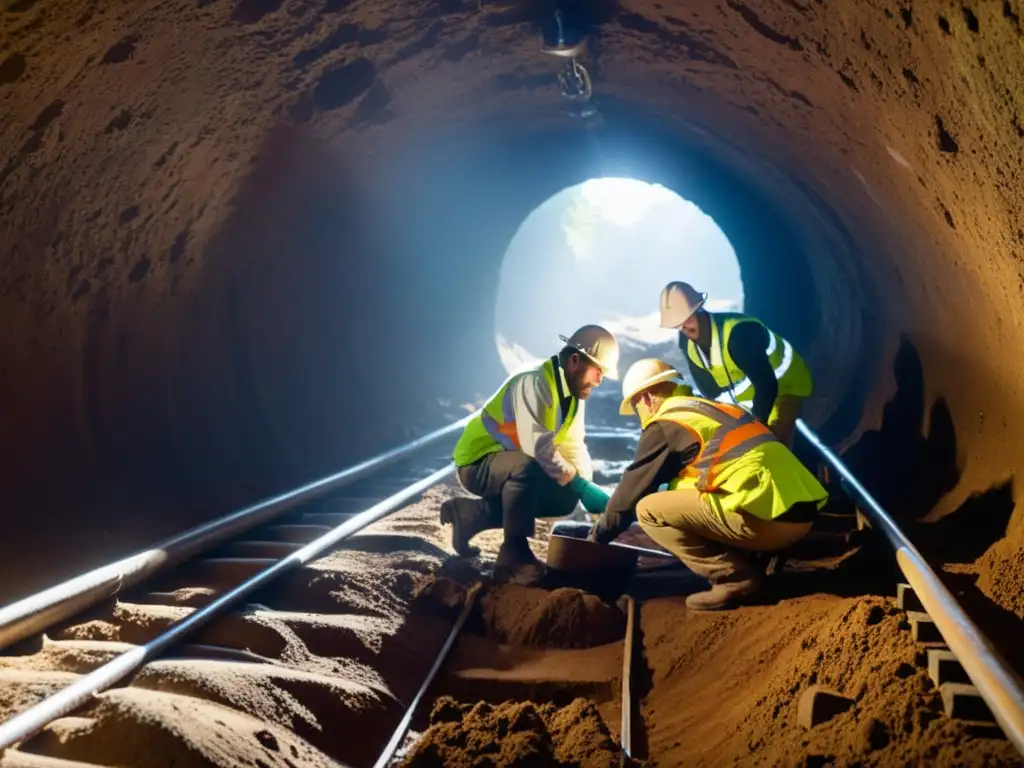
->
[[0, 464, 455, 750]]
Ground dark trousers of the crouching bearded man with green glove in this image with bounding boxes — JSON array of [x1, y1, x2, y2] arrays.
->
[[457, 451, 580, 540]]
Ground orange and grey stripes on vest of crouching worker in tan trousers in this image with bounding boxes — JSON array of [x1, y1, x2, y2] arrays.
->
[[652, 397, 777, 492]]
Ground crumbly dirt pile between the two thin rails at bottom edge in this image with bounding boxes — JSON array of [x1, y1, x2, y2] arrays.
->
[[402, 696, 620, 768]]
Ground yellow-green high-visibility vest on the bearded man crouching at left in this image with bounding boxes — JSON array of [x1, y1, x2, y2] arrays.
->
[[452, 356, 580, 467]]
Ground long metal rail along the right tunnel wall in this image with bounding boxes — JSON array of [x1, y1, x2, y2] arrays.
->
[[797, 419, 1024, 755]]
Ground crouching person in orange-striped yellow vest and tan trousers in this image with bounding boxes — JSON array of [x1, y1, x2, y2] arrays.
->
[[589, 358, 827, 610]]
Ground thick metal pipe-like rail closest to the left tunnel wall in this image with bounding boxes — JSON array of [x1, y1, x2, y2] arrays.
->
[[0, 414, 476, 650]]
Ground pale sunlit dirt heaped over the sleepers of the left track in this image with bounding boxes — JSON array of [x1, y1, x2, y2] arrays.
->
[[0, 501, 452, 768]]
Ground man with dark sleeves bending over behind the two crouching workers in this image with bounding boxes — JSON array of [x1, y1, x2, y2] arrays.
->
[[659, 282, 813, 447]]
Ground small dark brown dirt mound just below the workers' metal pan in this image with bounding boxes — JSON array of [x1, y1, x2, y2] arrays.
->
[[480, 585, 626, 648]]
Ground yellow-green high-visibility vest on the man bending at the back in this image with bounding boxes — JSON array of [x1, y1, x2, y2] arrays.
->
[[686, 312, 813, 403]]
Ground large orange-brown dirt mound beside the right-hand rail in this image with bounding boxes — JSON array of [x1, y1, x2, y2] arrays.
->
[[643, 595, 1019, 766]]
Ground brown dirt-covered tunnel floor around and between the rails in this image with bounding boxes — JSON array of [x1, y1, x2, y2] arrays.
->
[[0, 486, 1019, 768]]
